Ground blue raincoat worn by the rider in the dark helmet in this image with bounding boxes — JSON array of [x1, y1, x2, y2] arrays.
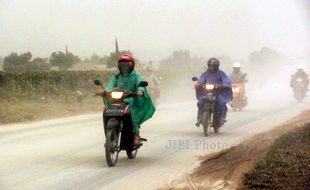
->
[[196, 70, 233, 125]]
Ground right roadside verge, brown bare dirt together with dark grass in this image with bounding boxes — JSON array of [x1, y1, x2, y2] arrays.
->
[[160, 110, 310, 190]]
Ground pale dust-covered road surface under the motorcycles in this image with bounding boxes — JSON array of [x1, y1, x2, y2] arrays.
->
[[0, 90, 310, 190]]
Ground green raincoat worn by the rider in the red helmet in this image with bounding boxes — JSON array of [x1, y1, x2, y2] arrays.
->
[[103, 71, 155, 133]]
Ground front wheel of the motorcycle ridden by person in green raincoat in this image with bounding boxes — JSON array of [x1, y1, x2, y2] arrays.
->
[[105, 128, 119, 167]]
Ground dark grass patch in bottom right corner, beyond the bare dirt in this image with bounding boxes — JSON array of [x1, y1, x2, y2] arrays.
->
[[240, 123, 310, 190]]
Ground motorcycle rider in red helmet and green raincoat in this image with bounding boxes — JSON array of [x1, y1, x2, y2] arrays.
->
[[96, 54, 155, 145]]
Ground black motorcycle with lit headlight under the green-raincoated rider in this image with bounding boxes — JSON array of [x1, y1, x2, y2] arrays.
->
[[94, 80, 148, 167]]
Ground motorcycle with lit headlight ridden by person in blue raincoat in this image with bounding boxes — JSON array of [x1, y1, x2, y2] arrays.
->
[[192, 77, 225, 136]]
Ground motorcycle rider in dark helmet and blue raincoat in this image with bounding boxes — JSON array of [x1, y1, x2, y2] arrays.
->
[[196, 57, 233, 127]]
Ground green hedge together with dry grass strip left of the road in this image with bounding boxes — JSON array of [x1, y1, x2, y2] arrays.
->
[[0, 70, 112, 124]]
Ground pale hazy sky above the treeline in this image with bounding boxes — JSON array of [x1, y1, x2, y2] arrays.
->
[[0, 0, 310, 60]]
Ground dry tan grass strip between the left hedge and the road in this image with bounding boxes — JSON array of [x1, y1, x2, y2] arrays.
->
[[0, 97, 103, 124]]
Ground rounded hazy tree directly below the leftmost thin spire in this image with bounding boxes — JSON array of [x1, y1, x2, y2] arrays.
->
[[50, 51, 80, 70]]
